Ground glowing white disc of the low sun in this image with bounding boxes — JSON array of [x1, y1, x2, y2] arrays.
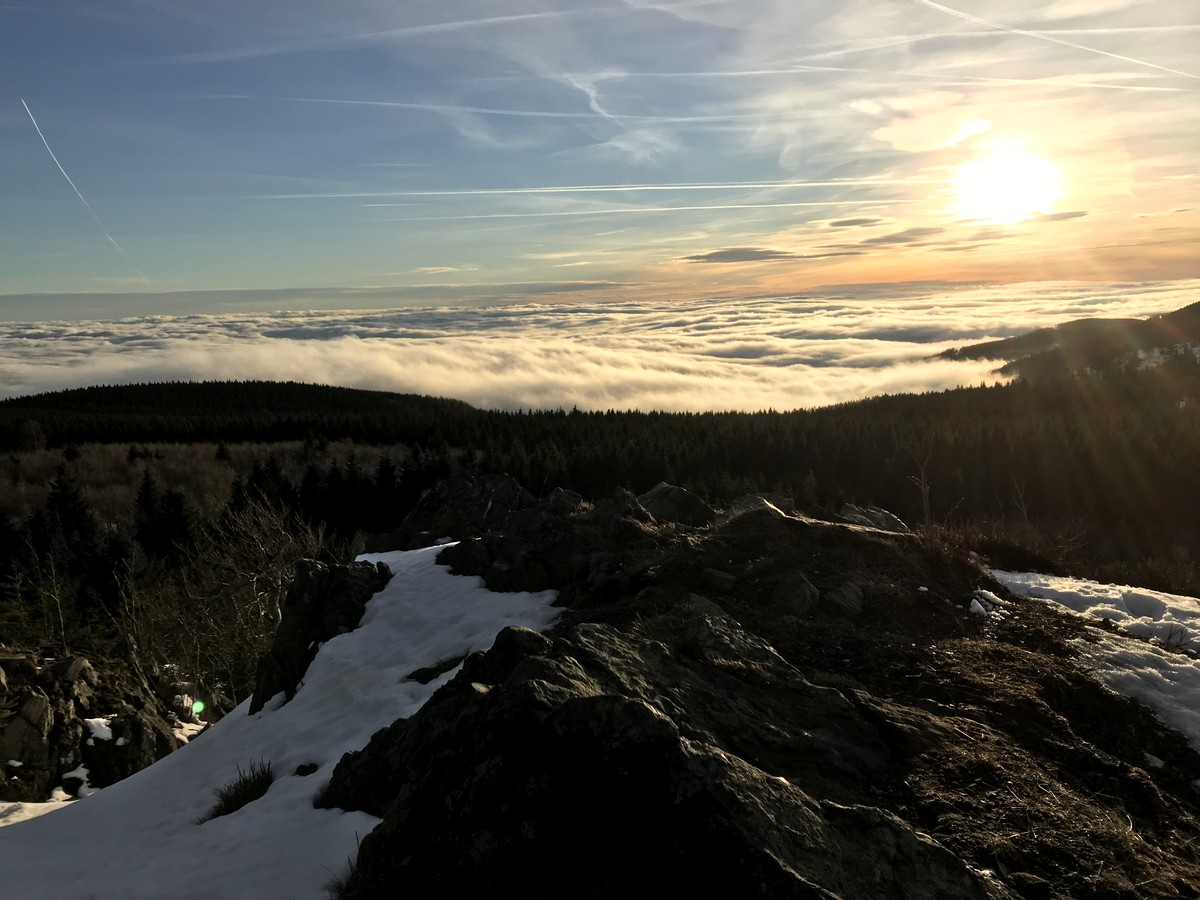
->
[[955, 146, 1062, 224]]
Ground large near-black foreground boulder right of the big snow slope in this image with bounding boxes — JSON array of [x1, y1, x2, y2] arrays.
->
[[322, 602, 1004, 900]]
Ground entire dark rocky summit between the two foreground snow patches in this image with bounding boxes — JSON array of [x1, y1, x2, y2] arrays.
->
[[318, 479, 1200, 899]]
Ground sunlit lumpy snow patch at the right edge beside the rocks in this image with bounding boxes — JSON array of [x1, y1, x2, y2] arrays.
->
[[992, 578, 1200, 751]]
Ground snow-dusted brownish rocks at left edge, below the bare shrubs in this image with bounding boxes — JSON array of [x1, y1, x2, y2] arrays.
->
[[0, 652, 180, 802]]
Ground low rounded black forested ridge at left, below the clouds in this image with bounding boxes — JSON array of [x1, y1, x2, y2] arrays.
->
[[0, 382, 476, 451]]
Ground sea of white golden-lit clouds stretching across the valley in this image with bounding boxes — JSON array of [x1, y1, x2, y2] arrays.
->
[[0, 281, 1200, 410]]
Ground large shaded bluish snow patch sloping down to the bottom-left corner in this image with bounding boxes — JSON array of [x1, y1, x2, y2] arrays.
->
[[0, 547, 558, 900]]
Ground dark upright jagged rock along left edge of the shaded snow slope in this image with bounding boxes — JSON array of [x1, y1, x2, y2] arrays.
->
[[250, 559, 391, 714]]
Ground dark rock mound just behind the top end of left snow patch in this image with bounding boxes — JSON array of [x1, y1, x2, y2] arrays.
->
[[400, 475, 532, 550]]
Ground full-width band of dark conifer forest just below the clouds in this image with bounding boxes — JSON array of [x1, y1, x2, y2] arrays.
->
[[0, 370, 1200, 547]]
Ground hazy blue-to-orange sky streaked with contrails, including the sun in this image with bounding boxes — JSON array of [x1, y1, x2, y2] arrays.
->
[[0, 0, 1200, 319]]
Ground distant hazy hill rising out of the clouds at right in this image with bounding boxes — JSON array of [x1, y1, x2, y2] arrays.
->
[[942, 296, 1200, 380]]
